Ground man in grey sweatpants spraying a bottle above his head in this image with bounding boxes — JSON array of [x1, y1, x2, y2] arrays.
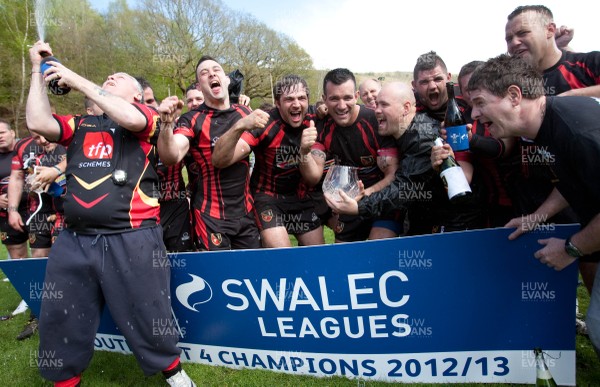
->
[[26, 41, 195, 386]]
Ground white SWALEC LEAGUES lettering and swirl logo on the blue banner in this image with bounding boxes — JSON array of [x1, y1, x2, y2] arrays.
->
[[176, 270, 412, 339]]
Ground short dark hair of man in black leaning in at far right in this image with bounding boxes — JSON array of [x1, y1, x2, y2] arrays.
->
[[467, 54, 545, 99]]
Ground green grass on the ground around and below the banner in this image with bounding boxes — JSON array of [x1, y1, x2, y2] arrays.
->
[[0, 239, 600, 387]]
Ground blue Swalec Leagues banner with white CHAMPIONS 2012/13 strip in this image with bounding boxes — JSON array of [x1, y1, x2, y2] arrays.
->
[[0, 225, 578, 385]]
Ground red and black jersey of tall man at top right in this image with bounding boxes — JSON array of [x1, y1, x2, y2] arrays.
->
[[543, 51, 600, 96]]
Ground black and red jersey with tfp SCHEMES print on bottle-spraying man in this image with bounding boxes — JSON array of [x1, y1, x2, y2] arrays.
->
[[54, 103, 160, 234]]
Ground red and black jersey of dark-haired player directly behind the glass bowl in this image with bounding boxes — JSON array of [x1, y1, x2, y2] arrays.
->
[[313, 105, 398, 188]]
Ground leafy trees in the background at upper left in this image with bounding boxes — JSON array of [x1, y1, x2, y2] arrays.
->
[[0, 0, 312, 132]]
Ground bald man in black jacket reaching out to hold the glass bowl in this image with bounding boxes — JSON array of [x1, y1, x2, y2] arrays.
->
[[325, 82, 445, 235]]
